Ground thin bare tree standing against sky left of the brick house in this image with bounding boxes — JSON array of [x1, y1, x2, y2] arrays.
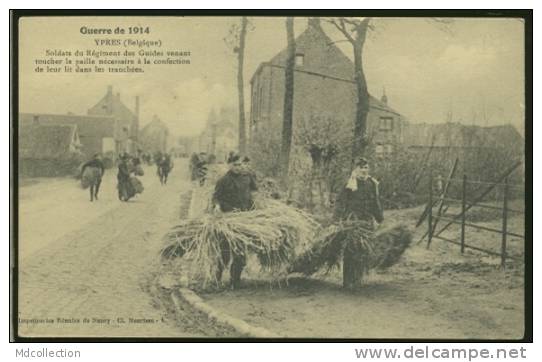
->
[[224, 16, 249, 153]]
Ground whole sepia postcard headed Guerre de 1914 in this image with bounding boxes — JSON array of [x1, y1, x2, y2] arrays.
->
[[10, 10, 533, 340]]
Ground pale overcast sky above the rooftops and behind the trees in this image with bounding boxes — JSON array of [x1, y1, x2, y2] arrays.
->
[[19, 17, 524, 138]]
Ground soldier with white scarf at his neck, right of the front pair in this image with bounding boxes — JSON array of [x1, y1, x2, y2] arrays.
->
[[335, 158, 384, 289]]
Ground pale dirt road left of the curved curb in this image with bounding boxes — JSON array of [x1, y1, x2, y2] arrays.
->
[[19, 162, 232, 337]]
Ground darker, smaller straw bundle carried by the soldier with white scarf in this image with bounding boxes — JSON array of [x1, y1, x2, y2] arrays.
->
[[288, 222, 412, 275]]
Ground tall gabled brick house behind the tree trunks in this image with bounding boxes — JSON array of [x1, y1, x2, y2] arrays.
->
[[249, 18, 404, 161]]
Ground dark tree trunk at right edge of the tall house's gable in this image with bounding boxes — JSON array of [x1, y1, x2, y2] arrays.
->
[[352, 18, 370, 161]]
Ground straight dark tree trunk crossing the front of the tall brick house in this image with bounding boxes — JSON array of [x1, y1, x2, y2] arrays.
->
[[280, 17, 295, 185]]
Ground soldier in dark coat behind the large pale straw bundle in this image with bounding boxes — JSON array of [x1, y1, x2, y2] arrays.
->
[[213, 155, 257, 288]]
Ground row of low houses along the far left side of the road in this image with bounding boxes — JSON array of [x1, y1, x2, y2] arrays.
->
[[18, 86, 168, 176]]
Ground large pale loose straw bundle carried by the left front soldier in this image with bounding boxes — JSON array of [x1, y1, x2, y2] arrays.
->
[[161, 200, 324, 285]]
